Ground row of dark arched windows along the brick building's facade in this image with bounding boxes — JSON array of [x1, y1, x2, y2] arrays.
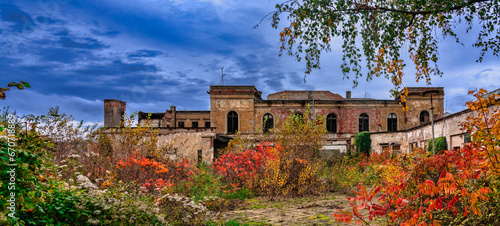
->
[[227, 111, 429, 134]]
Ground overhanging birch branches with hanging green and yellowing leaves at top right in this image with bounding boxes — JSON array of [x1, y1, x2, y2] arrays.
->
[[269, 0, 500, 91]]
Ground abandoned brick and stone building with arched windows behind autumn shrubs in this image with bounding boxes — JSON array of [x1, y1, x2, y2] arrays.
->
[[104, 86, 465, 162]]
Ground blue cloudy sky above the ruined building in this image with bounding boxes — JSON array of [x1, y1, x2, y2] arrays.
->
[[0, 0, 500, 123]]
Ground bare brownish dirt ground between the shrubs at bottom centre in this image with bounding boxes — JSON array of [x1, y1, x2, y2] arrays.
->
[[223, 193, 364, 225]]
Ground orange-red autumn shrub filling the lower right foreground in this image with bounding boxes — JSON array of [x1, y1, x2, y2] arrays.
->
[[334, 90, 500, 225]]
